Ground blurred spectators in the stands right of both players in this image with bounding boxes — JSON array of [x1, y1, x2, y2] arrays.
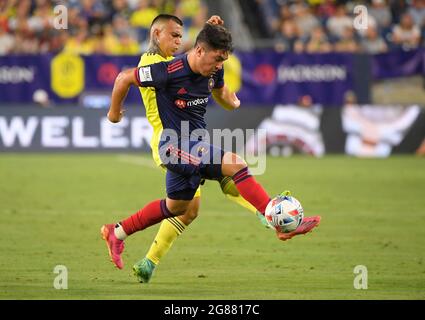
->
[[255, 0, 425, 54]]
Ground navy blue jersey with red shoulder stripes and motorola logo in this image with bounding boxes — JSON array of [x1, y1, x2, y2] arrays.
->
[[136, 54, 224, 137]]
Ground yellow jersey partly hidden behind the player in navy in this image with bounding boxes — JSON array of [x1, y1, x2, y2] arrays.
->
[[138, 53, 174, 166]]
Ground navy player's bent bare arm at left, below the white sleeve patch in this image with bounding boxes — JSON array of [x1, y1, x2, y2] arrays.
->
[[108, 68, 138, 123]]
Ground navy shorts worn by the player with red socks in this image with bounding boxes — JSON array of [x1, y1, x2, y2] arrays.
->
[[159, 140, 224, 200]]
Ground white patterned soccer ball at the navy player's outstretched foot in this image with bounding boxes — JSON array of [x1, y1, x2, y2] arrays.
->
[[265, 192, 304, 233]]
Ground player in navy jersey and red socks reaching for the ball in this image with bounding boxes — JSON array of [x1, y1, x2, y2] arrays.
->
[[102, 24, 320, 282]]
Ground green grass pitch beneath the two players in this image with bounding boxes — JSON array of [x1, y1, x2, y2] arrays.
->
[[0, 154, 425, 300]]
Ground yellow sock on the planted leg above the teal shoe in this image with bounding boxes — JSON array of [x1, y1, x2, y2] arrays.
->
[[146, 217, 186, 264]]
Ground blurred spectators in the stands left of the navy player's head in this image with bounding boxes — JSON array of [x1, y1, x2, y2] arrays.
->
[[0, 0, 207, 56]]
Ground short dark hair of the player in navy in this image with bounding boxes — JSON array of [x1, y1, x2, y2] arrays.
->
[[195, 23, 233, 52]]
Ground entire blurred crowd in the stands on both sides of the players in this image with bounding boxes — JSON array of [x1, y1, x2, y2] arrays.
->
[[0, 0, 425, 55]]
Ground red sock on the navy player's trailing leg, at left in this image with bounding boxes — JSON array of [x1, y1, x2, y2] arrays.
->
[[121, 199, 173, 236]]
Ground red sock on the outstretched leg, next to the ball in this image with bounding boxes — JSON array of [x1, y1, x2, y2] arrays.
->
[[232, 167, 270, 214]]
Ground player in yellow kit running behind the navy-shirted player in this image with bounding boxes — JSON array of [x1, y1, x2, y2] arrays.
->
[[102, 14, 318, 283]]
